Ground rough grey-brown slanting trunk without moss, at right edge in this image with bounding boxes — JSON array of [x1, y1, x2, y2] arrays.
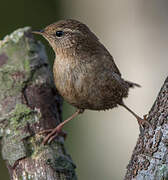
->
[[125, 77, 168, 180]]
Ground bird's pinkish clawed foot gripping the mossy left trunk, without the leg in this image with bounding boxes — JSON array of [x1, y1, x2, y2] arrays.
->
[[38, 125, 67, 145]]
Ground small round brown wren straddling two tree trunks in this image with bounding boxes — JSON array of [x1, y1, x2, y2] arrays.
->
[[32, 19, 150, 144]]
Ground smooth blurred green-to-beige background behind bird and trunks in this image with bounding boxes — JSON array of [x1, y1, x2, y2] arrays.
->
[[0, 0, 168, 180]]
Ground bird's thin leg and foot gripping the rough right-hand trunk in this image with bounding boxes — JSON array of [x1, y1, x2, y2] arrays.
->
[[120, 102, 152, 128]]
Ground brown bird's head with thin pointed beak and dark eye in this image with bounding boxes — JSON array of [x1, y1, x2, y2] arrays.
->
[[33, 19, 97, 54]]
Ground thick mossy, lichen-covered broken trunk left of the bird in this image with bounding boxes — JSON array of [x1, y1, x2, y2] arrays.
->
[[0, 27, 77, 180]]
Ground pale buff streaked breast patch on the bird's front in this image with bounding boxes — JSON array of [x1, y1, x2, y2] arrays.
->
[[53, 57, 87, 106]]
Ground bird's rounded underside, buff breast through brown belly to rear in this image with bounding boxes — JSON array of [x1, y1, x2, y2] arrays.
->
[[54, 59, 127, 110]]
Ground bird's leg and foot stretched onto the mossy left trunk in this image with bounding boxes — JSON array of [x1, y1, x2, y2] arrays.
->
[[39, 109, 84, 144]]
